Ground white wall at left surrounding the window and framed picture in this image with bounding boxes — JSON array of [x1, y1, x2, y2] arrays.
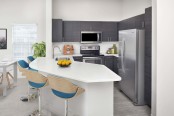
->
[[0, 0, 45, 59]]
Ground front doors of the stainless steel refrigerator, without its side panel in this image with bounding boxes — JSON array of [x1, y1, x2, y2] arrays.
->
[[119, 30, 136, 102]]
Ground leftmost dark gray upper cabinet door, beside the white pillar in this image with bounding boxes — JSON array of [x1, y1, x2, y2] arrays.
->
[[52, 19, 63, 42]]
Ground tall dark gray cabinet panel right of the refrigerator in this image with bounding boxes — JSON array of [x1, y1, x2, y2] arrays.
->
[[144, 7, 152, 106]]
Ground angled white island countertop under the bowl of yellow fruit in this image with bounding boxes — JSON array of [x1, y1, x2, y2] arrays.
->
[[30, 56, 121, 83]]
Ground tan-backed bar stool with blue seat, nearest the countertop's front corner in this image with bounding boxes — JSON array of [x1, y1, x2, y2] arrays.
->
[[48, 76, 85, 116]]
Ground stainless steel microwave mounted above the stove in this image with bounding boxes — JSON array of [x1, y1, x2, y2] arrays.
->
[[81, 31, 102, 43]]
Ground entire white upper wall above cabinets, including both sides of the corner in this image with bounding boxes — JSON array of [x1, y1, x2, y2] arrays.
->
[[53, 0, 152, 21]]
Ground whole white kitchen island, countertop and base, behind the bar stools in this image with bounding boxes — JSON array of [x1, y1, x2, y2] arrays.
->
[[30, 57, 121, 116]]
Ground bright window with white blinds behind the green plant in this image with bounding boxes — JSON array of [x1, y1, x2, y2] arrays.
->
[[12, 24, 37, 60]]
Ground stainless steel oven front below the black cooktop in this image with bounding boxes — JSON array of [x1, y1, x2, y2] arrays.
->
[[83, 57, 103, 64]]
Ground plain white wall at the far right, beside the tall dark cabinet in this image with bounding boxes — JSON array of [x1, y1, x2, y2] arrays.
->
[[153, 0, 174, 116]]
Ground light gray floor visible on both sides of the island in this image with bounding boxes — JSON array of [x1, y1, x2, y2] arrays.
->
[[0, 79, 150, 116]]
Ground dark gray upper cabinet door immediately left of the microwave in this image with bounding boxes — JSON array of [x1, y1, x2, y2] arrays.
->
[[64, 21, 80, 42]]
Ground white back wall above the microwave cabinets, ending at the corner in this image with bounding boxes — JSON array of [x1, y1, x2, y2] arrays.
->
[[53, 0, 122, 21]]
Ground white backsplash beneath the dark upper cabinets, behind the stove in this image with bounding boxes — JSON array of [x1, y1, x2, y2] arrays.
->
[[53, 42, 119, 55]]
